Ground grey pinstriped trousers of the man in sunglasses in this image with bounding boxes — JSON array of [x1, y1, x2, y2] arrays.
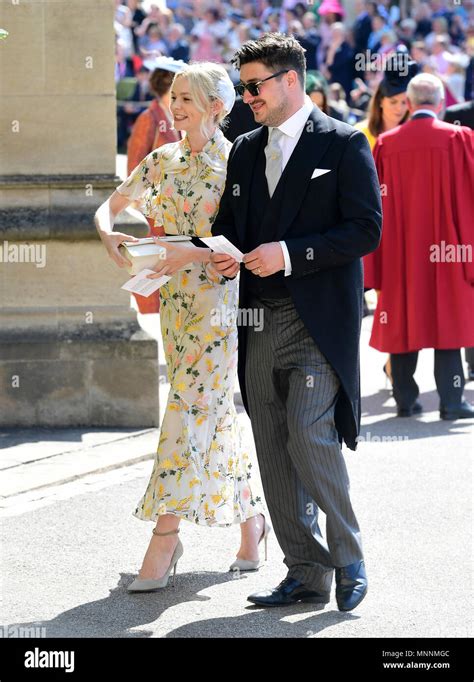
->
[[245, 297, 363, 593]]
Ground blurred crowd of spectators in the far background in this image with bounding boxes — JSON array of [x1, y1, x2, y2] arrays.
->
[[114, 0, 474, 146]]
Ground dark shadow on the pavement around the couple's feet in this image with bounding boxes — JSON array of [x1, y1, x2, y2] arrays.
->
[[5, 571, 358, 639]]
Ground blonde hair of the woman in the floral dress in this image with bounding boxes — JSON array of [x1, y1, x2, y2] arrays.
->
[[171, 62, 231, 135]]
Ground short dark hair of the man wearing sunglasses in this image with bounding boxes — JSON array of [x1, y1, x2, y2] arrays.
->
[[232, 33, 306, 88]]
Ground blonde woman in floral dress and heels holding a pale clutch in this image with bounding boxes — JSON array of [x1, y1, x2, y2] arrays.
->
[[96, 63, 270, 592]]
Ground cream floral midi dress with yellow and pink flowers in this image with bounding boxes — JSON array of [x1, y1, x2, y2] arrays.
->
[[117, 129, 263, 526]]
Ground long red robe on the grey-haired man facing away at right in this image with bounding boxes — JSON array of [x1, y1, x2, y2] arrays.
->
[[364, 117, 474, 353]]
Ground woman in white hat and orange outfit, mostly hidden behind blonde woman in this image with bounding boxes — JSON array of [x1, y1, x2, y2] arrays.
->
[[127, 57, 185, 314]]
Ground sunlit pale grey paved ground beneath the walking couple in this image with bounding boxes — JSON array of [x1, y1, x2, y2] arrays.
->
[[0, 304, 474, 637]]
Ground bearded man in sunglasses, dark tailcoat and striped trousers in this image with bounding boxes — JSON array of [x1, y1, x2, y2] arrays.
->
[[211, 34, 381, 611]]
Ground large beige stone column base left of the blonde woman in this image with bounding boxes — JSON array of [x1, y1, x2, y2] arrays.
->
[[0, 0, 159, 427]]
